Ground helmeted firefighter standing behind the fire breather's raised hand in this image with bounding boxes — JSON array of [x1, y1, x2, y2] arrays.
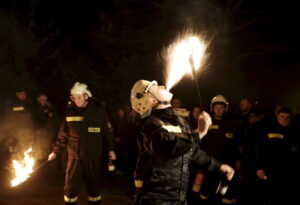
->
[[200, 95, 240, 204]]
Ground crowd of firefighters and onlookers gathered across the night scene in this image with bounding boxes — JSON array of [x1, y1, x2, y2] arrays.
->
[[0, 81, 300, 205]]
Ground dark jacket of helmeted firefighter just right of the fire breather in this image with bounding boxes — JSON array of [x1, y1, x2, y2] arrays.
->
[[201, 117, 240, 166]]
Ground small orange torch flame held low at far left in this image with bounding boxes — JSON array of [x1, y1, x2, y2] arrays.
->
[[11, 147, 34, 186]]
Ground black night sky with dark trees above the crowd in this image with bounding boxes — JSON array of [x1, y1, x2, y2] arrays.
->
[[0, 0, 300, 113]]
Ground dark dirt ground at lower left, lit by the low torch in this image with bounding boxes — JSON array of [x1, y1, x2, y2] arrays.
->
[[0, 162, 133, 205]]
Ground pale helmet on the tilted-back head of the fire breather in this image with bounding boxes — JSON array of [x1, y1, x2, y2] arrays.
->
[[130, 80, 157, 118]]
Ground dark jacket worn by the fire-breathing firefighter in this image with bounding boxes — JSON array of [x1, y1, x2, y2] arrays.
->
[[135, 108, 220, 201]]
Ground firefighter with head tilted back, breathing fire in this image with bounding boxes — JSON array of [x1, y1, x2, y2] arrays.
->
[[131, 80, 234, 205]]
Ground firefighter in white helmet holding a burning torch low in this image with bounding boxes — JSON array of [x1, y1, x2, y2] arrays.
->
[[48, 82, 116, 205]]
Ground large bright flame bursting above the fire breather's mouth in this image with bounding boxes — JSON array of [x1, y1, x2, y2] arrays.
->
[[166, 35, 206, 90]]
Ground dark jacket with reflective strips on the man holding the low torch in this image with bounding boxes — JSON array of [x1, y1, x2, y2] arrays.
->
[[54, 102, 113, 159]]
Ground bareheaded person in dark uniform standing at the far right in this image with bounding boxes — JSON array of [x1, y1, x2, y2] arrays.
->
[[256, 107, 299, 205]]
